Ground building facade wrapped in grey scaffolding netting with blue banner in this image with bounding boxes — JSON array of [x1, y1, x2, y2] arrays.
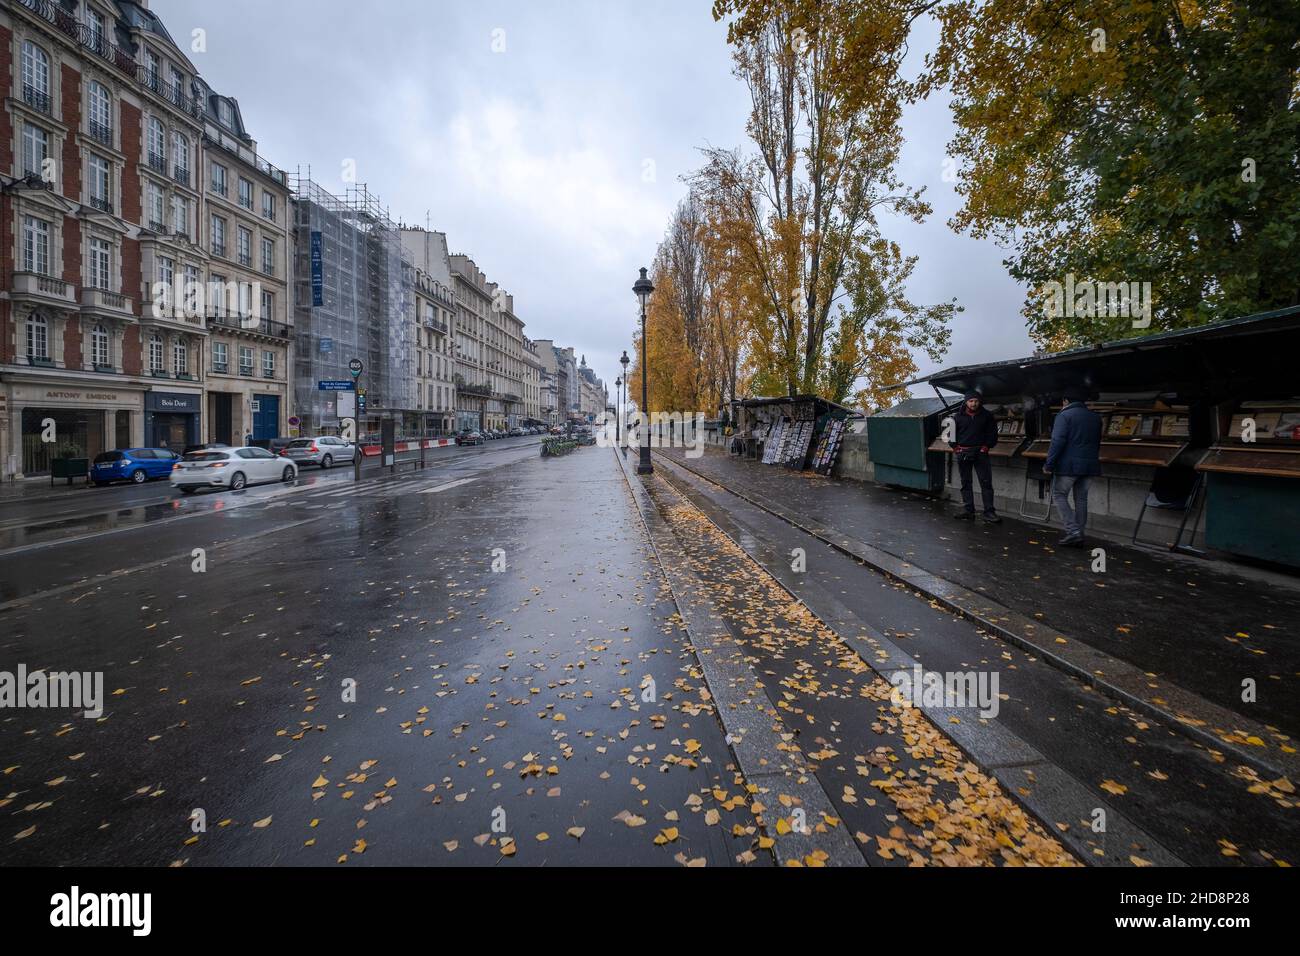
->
[[289, 166, 417, 434]]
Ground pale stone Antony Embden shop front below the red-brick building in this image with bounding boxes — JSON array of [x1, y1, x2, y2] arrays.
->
[[0, 380, 143, 480]]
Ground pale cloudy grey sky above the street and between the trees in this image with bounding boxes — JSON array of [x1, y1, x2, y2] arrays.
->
[[150, 0, 1031, 395]]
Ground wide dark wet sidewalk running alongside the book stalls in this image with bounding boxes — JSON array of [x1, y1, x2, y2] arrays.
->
[[657, 447, 1300, 766]]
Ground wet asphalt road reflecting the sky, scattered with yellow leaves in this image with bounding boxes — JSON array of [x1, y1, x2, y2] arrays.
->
[[0, 440, 771, 866]]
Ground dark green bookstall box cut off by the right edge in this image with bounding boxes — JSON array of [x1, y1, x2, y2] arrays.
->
[[1196, 398, 1300, 567]]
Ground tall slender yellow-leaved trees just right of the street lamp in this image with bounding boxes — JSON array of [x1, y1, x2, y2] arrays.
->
[[639, 0, 958, 407]]
